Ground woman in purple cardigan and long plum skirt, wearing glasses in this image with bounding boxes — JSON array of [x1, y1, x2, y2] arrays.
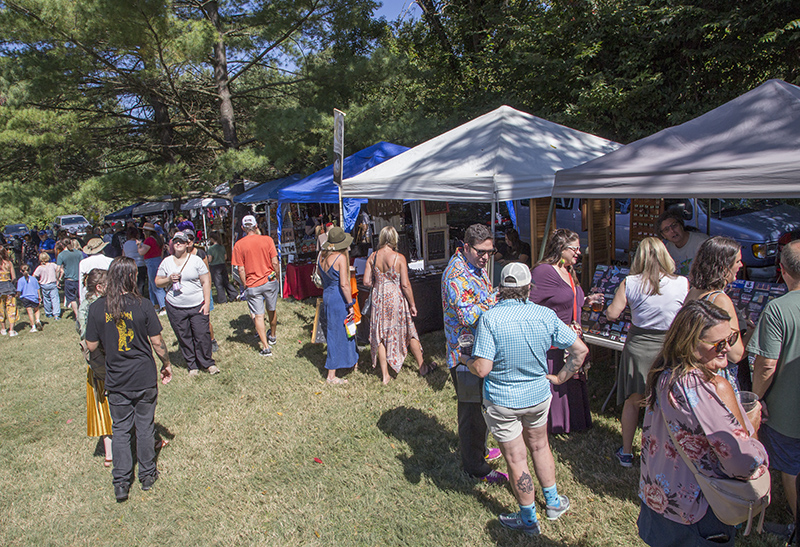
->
[[530, 228, 603, 434]]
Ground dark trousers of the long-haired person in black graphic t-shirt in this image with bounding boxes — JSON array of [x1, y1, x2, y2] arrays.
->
[[108, 387, 158, 486]]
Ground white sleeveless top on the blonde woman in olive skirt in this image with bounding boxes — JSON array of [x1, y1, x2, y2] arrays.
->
[[625, 274, 689, 330]]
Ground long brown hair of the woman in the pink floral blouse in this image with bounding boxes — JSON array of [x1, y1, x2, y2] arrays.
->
[[645, 300, 731, 409]]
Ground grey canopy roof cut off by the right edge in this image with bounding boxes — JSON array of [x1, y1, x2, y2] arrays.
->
[[553, 80, 800, 198]]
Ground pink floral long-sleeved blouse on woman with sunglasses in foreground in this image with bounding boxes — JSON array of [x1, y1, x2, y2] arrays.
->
[[639, 371, 767, 524]]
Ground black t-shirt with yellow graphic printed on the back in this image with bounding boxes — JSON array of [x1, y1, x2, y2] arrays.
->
[[86, 294, 161, 391]]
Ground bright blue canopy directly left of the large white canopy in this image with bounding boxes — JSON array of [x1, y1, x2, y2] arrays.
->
[[278, 141, 408, 232]]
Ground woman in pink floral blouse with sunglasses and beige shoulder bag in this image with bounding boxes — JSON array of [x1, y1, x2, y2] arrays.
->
[[638, 300, 768, 547]]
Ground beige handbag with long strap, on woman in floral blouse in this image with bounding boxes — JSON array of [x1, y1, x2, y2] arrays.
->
[[661, 404, 771, 536]]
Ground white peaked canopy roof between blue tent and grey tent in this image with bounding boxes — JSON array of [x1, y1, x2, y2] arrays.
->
[[342, 106, 620, 202]]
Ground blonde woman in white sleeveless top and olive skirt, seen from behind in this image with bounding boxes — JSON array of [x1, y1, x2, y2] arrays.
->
[[606, 237, 689, 467]]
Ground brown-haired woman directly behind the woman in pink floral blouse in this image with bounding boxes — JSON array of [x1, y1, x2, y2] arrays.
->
[[686, 236, 755, 396]]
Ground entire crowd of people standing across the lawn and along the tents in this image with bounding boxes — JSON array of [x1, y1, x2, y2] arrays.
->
[[0, 213, 800, 546]]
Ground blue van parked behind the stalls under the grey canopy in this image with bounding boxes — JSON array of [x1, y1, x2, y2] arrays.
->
[[515, 198, 800, 281]]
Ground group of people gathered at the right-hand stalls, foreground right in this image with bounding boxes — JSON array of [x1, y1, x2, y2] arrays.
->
[[442, 220, 800, 546]]
